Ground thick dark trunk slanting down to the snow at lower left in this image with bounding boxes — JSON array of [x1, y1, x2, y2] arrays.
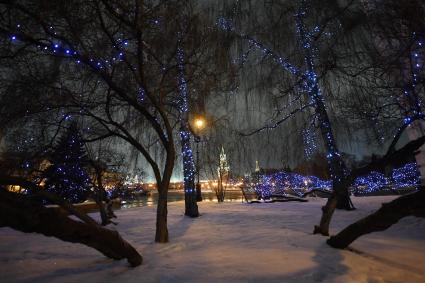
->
[[0, 190, 143, 266]]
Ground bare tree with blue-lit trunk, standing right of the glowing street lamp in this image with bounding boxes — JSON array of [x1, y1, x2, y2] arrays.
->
[[218, 1, 423, 235]]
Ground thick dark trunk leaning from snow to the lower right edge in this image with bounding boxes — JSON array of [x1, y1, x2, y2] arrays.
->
[[327, 188, 425, 249]]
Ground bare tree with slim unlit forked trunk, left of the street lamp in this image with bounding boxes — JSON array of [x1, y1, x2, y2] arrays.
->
[[0, 1, 222, 242]]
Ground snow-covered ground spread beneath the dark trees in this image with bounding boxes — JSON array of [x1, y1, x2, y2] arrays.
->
[[0, 197, 425, 283]]
